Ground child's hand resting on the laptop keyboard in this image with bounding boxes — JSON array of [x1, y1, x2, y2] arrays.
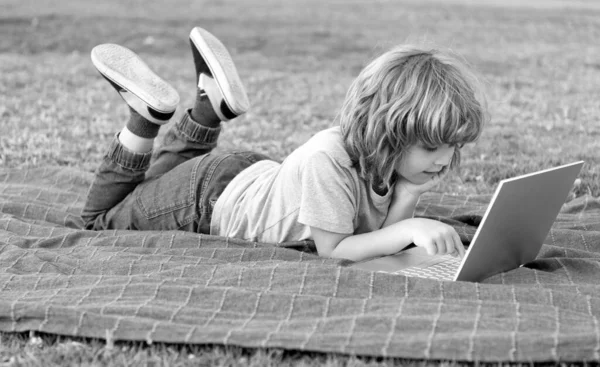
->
[[407, 218, 465, 258]]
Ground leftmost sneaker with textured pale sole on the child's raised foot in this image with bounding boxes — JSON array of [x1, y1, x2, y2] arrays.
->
[[91, 44, 179, 125]]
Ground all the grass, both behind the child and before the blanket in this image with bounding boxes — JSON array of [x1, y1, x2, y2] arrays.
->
[[0, 0, 600, 366]]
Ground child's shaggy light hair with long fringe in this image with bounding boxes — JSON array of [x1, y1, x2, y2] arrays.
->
[[338, 45, 487, 189]]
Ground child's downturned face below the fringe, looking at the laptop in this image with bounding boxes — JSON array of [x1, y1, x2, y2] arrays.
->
[[396, 143, 456, 185]]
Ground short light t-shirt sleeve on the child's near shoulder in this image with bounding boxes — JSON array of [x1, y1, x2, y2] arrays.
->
[[298, 152, 356, 234]]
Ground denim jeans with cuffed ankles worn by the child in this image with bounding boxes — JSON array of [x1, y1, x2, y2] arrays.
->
[[82, 111, 269, 234]]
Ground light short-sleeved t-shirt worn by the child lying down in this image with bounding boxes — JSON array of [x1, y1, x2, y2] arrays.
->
[[210, 127, 393, 243]]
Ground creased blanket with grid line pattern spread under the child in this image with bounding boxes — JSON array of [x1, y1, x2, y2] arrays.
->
[[0, 167, 600, 362]]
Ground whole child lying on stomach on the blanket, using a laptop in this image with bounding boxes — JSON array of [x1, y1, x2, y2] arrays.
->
[[82, 28, 486, 260]]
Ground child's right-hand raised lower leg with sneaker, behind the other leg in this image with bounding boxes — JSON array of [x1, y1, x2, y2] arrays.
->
[[146, 27, 249, 178]]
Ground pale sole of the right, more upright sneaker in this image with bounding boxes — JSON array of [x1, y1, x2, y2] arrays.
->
[[190, 27, 250, 116]]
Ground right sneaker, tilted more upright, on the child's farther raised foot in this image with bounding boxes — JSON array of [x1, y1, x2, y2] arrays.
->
[[190, 27, 250, 121]]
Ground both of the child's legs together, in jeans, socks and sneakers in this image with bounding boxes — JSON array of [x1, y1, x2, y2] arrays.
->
[[82, 28, 254, 232]]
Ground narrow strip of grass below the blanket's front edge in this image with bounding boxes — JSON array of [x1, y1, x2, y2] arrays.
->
[[0, 334, 422, 367]]
